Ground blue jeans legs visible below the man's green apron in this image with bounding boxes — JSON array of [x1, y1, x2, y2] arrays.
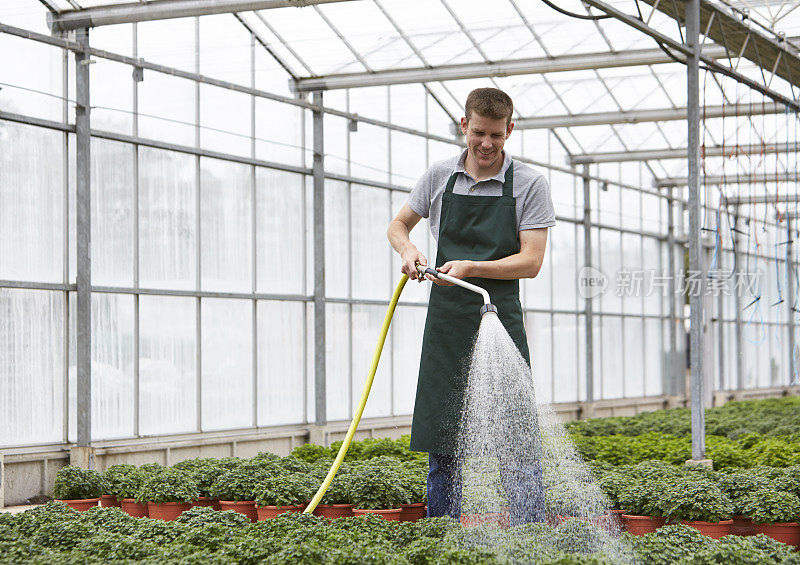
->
[[428, 453, 545, 526]]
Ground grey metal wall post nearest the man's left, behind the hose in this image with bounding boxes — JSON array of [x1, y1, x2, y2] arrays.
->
[[312, 91, 327, 426]]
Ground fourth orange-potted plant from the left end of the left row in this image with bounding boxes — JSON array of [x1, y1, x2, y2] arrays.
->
[[136, 467, 200, 521]]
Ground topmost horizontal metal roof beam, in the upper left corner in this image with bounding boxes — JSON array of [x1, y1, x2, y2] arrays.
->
[[47, 0, 350, 33]]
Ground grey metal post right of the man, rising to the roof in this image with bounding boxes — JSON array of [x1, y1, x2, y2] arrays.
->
[[686, 0, 706, 462]]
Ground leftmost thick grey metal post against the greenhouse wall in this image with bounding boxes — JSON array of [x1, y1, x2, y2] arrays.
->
[[75, 29, 92, 454]]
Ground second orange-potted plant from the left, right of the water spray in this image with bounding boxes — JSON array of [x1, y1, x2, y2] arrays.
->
[[662, 477, 733, 539]]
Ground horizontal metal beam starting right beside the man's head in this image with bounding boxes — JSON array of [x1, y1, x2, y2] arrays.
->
[[514, 102, 786, 129]]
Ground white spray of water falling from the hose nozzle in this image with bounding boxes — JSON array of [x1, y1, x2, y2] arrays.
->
[[457, 313, 631, 563]]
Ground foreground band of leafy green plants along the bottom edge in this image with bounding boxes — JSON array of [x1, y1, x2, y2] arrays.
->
[[0, 502, 798, 565]]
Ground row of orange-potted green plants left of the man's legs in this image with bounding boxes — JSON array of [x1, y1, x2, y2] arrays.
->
[[53, 453, 427, 521]]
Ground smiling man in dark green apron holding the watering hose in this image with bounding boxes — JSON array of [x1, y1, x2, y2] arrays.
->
[[387, 88, 555, 523]]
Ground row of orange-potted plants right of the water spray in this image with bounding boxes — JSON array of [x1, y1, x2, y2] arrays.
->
[[596, 461, 800, 547]]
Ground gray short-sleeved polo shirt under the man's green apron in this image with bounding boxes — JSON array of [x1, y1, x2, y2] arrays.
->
[[408, 149, 556, 241]]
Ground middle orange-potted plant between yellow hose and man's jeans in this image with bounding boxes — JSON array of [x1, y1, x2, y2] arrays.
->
[[350, 465, 410, 521]]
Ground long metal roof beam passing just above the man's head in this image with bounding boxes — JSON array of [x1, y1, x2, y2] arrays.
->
[[289, 45, 725, 92]]
